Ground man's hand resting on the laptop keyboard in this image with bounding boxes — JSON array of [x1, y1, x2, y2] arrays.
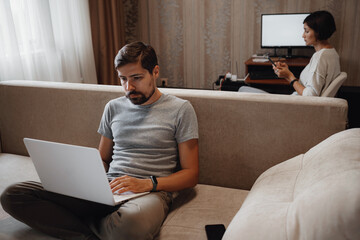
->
[[110, 176, 153, 194]]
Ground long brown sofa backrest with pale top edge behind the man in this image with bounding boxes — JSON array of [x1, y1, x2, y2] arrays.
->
[[0, 80, 347, 189]]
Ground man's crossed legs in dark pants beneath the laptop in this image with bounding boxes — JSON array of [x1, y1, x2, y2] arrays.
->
[[1, 182, 172, 240]]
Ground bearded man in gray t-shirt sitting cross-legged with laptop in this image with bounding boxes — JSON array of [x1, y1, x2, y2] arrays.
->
[[1, 42, 199, 239]]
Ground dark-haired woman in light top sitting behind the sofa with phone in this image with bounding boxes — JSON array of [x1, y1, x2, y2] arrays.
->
[[239, 11, 340, 96]]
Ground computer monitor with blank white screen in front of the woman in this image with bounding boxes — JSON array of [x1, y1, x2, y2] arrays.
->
[[261, 13, 309, 57]]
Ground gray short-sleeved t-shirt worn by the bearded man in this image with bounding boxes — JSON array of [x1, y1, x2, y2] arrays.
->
[[98, 94, 198, 180]]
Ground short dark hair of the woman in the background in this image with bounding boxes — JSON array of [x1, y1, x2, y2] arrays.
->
[[304, 11, 336, 41]]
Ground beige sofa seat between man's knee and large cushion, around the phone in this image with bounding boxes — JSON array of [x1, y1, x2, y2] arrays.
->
[[157, 184, 249, 240]]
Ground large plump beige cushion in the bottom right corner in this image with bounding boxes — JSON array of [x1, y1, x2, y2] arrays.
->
[[223, 129, 360, 239]]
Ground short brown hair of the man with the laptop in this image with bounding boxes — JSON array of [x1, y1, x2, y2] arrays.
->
[[114, 42, 158, 74]]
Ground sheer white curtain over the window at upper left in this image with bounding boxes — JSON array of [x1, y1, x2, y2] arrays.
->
[[0, 0, 97, 84]]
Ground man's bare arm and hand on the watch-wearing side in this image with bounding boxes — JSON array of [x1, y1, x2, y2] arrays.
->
[[110, 139, 199, 193]]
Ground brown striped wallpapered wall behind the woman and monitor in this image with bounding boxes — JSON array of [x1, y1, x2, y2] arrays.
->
[[128, 0, 360, 89]]
